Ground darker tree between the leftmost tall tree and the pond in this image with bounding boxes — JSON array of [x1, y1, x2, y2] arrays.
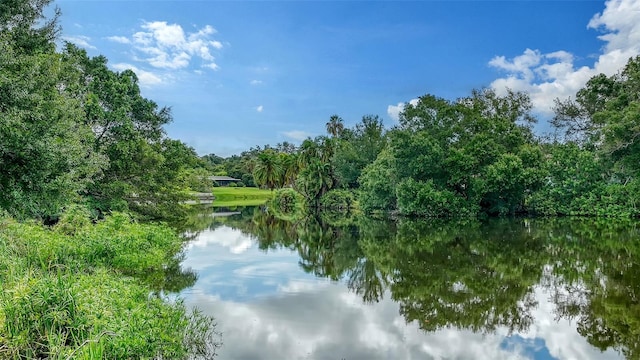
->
[[63, 44, 198, 217]]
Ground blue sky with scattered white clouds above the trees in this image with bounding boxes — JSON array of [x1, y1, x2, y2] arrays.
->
[[55, 0, 640, 156]]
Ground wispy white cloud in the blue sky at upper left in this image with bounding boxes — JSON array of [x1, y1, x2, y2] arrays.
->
[[124, 21, 223, 70]]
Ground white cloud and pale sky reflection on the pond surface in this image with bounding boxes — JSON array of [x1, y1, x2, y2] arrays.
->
[[182, 226, 620, 360]]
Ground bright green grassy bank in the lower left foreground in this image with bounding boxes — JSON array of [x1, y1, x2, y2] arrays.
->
[[0, 207, 216, 359]]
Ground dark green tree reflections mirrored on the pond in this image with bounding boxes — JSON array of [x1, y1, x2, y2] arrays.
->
[[180, 208, 640, 359]]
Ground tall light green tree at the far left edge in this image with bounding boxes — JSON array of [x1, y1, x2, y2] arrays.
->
[[0, 0, 106, 219]]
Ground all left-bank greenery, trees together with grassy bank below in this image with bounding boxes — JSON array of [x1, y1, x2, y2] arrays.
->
[[0, 0, 218, 359]]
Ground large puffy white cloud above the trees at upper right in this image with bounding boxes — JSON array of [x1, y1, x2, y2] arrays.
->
[[488, 0, 640, 115]]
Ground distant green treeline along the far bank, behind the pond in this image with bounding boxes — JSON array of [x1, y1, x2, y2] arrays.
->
[[203, 57, 640, 217]]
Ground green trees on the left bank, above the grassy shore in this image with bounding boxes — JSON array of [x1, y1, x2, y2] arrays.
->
[[0, 0, 210, 220]]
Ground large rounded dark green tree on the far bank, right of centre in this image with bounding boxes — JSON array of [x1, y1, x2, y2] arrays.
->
[[361, 90, 544, 216]]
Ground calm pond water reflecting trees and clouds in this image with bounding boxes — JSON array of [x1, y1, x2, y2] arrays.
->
[[181, 208, 640, 360]]
